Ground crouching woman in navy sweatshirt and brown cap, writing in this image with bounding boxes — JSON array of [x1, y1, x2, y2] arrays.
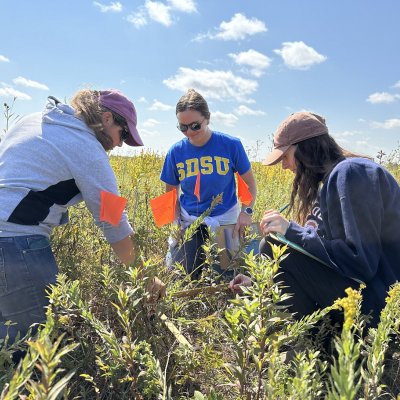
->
[[231, 112, 400, 326]]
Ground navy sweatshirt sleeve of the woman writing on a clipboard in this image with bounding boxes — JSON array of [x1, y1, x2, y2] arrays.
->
[[286, 161, 383, 282]]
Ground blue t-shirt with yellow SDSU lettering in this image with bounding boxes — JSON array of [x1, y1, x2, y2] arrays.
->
[[160, 132, 250, 216]]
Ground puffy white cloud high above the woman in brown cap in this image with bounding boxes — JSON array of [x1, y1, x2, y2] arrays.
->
[[274, 42, 327, 70]]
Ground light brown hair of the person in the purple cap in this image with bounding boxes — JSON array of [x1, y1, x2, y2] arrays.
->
[[71, 89, 127, 150]]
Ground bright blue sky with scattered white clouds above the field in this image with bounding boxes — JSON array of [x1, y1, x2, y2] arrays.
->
[[0, 0, 400, 159]]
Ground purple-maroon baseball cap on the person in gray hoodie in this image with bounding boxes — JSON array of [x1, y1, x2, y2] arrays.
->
[[100, 89, 143, 146]]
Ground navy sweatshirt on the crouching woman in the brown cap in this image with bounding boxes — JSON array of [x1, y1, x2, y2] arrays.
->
[[285, 158, 400, 325]]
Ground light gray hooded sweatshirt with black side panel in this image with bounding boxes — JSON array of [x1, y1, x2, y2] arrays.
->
[[0, 100, 132, 243]]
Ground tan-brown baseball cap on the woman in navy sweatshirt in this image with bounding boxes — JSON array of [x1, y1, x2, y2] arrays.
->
[[263, 111, 328, 165]]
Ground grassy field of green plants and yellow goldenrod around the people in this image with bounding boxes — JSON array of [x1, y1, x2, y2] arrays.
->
[[0, 153, 400, 400]]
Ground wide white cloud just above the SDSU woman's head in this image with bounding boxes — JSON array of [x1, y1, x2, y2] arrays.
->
[[163, 67, 258, 103]]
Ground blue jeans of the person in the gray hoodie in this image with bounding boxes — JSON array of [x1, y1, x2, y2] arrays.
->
[[0, 235, 58, 342]]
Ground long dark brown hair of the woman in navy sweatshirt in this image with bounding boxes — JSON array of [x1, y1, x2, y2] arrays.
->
[[290, 134, 368, 224]]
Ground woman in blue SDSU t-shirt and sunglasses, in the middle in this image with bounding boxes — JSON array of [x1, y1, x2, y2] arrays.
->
[[161, 89, 256, 279]]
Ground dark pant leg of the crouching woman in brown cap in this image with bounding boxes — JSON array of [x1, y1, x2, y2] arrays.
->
[[260, 237, 360, 319]]
